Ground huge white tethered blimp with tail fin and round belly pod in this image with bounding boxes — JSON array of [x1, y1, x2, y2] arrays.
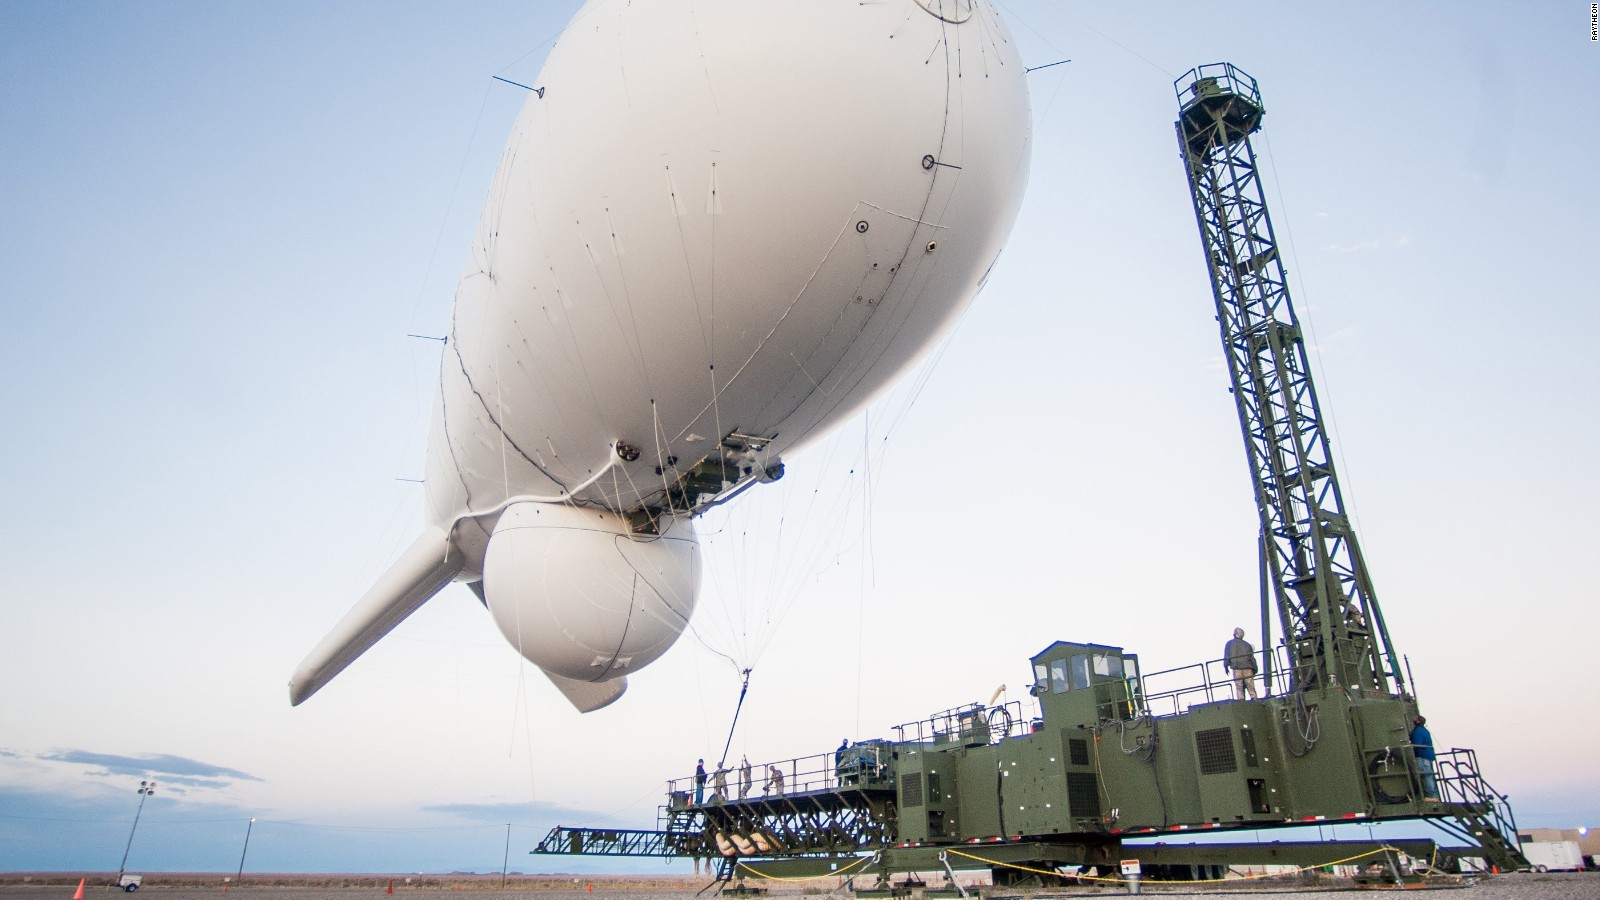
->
[[294, 0, 1029, 708]]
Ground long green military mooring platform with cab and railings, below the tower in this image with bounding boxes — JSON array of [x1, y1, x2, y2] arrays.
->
[[536, 641, 1517, 882]]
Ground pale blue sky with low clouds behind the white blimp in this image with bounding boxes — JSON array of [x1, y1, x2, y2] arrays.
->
[[0, 0, 1600, 871]]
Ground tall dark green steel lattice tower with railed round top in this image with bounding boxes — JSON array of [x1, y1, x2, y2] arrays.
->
[[1174, 62, 1405, 693]]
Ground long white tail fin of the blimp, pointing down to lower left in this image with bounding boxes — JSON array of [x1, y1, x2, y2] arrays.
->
[[290, 528, 464, 706]]
